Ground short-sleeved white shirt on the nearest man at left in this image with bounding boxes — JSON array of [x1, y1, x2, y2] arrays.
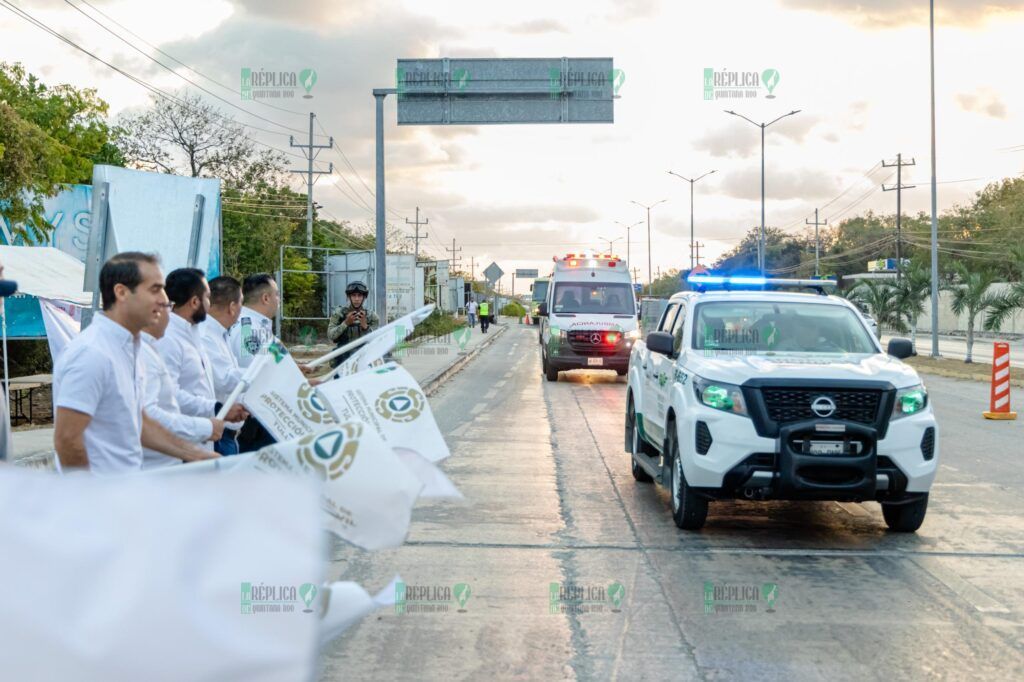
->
[[53, 312, 145, 474]]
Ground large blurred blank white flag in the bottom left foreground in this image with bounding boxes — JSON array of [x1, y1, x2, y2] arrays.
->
[[0, 467, 326, 682]]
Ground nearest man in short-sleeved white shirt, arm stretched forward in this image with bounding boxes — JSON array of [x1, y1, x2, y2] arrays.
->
[[53, 252, 216, 474]]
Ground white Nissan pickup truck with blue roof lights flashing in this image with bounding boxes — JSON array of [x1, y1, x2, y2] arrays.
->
[[626, 275, 939, 532]]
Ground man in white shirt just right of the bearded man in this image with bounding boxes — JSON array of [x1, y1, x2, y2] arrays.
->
[[200, 275, 242, 455]]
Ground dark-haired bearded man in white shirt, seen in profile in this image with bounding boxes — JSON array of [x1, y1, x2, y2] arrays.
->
[[156, 267, 247, 450]]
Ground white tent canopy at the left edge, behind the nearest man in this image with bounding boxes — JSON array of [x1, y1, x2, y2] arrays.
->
[[0, 246, 92, 306]]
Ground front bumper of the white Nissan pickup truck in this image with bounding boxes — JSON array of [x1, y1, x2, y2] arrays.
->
[[677, 406, 939, 501]]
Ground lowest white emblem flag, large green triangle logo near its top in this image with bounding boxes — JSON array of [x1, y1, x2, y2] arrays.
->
[[234, 421, 423, 550]]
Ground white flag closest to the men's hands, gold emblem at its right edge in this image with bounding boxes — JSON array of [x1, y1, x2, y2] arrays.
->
[[241, 341, 334, 441]]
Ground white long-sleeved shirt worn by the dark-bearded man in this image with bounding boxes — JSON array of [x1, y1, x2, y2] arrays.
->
[[157, 312, 217, 418]]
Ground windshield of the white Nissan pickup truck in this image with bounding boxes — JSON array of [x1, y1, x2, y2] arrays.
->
[[693, 301, 878, 354]]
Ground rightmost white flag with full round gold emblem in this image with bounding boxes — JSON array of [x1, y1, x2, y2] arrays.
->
[[316, 363, 451, 462]]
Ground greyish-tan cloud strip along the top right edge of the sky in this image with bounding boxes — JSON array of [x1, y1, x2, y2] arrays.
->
[[781, 0, 1024, 29]]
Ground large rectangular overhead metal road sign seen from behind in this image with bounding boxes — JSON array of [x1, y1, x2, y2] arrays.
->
[[395, 57, 625, 125]]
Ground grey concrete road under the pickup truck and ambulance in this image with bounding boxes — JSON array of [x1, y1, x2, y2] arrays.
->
[[321, 327, 1024, 680]]
